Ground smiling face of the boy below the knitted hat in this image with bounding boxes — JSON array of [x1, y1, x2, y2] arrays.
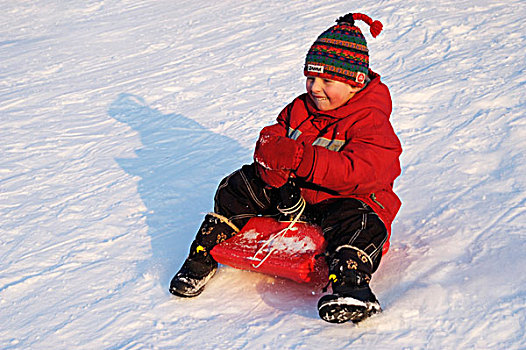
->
[[306, 76, 361, 111]]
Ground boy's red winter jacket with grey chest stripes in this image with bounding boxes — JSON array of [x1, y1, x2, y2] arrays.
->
[[261, 71, 402, 251]]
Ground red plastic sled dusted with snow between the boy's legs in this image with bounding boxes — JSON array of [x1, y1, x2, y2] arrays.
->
[[211, 217, 328, 285]]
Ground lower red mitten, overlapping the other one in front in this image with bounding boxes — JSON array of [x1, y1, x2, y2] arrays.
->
[[254, 134, 303, 170]]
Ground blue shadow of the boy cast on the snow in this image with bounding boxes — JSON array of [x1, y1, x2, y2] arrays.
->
[[108, 94, 251, 286]]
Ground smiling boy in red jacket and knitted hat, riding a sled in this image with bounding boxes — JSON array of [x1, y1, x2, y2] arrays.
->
[[170, 14, 402, 323]]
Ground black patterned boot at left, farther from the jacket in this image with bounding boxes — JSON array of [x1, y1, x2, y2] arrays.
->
[[170, 214, 234, 297]]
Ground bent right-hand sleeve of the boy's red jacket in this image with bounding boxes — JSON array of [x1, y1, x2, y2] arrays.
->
[[298, 109, 402, 195]]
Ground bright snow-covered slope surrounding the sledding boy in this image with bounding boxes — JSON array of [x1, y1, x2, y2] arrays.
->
[[0, 0, 526, 349]]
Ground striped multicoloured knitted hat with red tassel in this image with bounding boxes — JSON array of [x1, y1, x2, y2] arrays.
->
[[303, 13, 383, 87]]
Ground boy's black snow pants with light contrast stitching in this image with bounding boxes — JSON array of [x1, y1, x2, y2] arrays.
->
[[196, 164, 387, 272]]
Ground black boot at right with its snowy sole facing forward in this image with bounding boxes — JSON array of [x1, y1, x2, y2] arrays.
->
[[318, 248, 382, 323]]
